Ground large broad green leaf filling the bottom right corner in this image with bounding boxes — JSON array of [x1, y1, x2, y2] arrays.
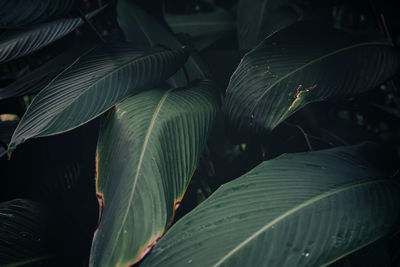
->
[[141, 144, 400, 266]]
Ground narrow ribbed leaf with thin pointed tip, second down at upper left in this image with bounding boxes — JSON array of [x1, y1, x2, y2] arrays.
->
[[0, 7, 104, 63]]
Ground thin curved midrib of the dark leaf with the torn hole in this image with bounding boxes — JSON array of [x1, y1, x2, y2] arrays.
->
[[250, 42, 391, 114]]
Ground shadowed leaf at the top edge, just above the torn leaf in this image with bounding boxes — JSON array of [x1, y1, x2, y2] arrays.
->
[[236, 0, 301, 50]]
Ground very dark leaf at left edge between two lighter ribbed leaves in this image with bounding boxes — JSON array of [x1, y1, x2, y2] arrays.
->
[[0, 44, 91, 100]]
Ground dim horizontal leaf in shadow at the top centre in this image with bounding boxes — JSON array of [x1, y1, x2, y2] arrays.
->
[[165, 9, 235, 38]]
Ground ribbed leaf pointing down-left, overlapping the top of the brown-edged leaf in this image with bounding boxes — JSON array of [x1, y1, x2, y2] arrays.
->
[[9, 45, 187, 151]]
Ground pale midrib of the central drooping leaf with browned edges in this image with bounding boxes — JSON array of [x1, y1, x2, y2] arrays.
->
[[110, 89, 174, 262]]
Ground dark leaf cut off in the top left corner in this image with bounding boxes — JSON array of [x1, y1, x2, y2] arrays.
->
[[0, 0, 75, 28]]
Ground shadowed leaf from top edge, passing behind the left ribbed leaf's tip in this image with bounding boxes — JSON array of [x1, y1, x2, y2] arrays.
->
[[117, 0, 207, 87]]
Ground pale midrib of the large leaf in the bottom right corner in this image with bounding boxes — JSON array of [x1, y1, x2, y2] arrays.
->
[[213, 179, 385, 267]]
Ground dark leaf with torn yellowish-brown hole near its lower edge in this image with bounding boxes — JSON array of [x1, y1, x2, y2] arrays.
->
[[227, 22, 400, 143]]
